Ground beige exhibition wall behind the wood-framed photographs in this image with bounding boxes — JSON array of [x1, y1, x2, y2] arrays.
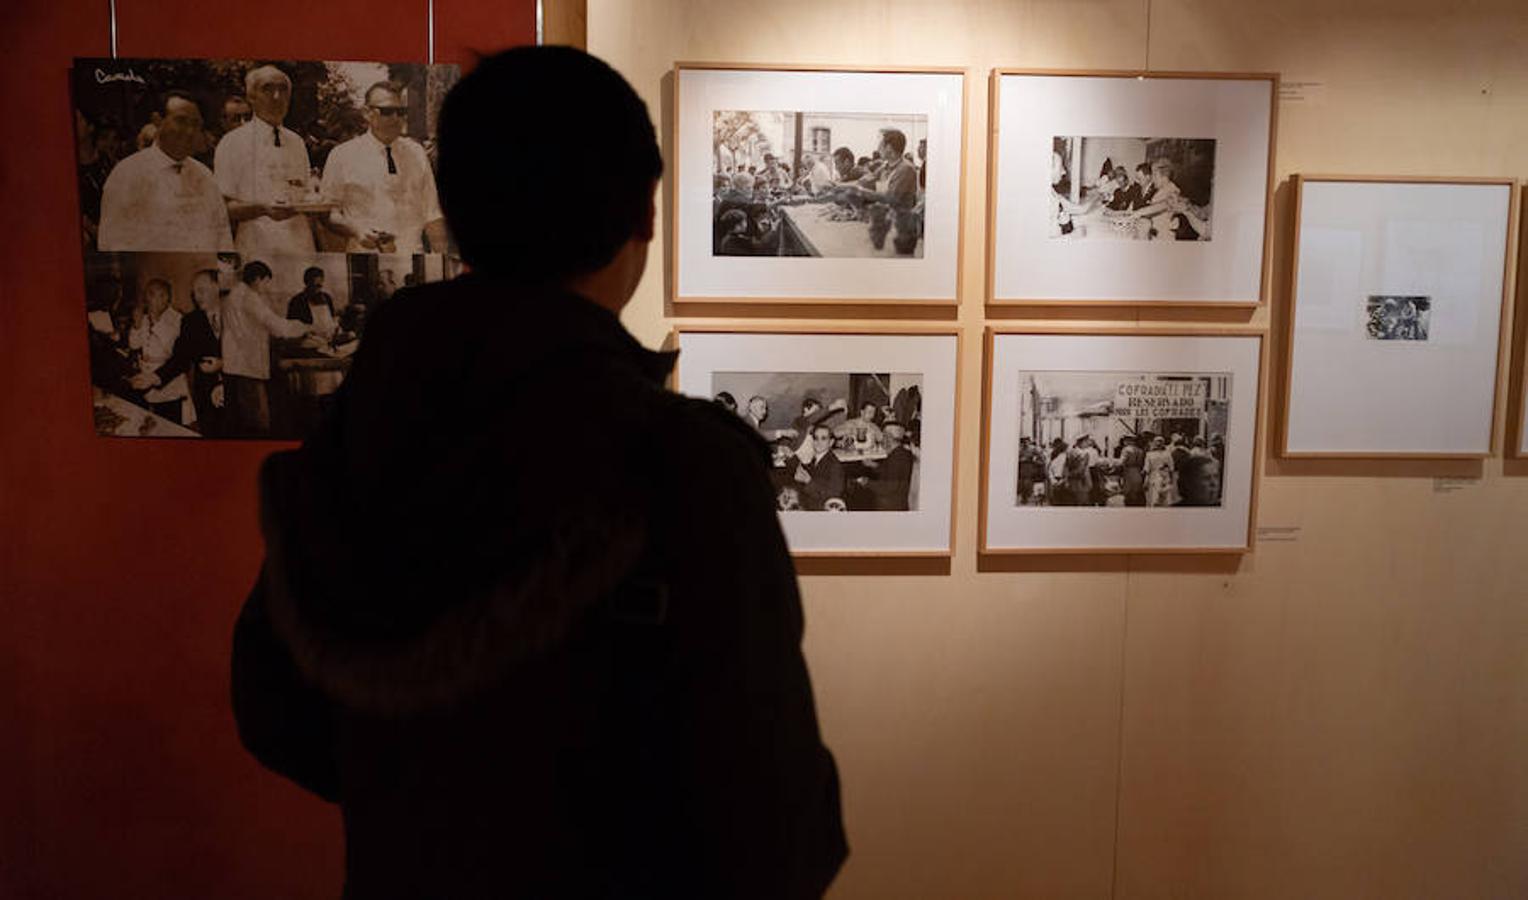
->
[[588, 0, 1528, 900]]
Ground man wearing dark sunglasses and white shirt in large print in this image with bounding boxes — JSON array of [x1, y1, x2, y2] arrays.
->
[[321, 81, 446, 254]]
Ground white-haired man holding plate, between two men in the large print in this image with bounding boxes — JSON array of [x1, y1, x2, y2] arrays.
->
[[212, 66, 313, 258]]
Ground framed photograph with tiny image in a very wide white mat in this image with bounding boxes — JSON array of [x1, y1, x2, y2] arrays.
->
[[1280, 176, 1516, 458]]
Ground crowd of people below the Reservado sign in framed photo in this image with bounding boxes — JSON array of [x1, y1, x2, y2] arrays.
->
[[1016, 431, 1225, 507]]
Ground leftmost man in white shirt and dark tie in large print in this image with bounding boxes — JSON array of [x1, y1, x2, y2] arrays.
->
[[96, 90, 234, 251]]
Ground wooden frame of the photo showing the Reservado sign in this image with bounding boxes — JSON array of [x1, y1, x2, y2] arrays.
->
[[976, 324, 1268, 556]]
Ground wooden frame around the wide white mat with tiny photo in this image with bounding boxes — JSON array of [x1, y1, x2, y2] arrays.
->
[[1279, 173, 1519, 460]]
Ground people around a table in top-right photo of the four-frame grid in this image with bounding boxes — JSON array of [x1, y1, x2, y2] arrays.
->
[[1051, 153, 1210, 240]]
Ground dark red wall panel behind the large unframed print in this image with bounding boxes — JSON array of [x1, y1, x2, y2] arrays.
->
[[0, 0, 535, 898]]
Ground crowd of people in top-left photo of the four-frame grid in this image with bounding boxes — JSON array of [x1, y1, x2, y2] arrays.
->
[[712, 128, 927, 257]]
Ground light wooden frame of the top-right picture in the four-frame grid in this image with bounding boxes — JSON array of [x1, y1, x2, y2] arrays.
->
[[986, 67, 1279, 309]]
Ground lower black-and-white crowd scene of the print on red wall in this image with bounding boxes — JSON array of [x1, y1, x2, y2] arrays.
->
[[86, 252, 451, 440]]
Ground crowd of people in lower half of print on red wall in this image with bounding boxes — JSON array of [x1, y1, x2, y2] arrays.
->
[[87, 254, 391, 437]]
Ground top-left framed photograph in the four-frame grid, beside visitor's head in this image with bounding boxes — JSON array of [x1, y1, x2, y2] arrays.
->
[[669, 63, 966, 304]]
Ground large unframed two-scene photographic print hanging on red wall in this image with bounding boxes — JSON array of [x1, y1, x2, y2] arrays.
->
[[73, 60, 458, 439]]
